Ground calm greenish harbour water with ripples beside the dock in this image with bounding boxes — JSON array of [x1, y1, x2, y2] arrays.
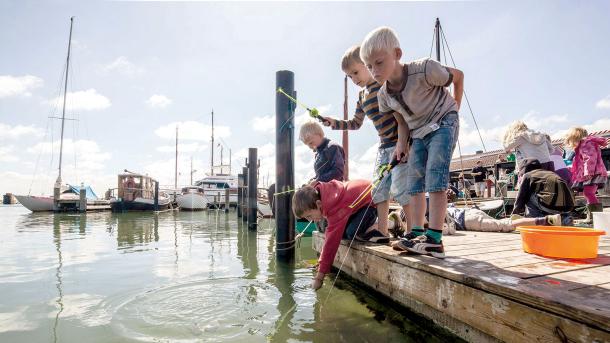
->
[[0, 206, 456, 343]]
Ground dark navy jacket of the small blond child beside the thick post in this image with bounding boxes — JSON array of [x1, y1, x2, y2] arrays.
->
[[313, 138, 345, 182]]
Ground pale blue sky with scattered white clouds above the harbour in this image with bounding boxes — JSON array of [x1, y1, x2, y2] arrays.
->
[[0, 0, 610, 195]]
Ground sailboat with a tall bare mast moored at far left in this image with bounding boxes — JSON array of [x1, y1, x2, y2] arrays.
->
[[15, 17, 109, 212]]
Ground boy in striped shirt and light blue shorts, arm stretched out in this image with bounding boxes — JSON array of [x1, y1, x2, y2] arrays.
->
[[324, 46, 410, 236]]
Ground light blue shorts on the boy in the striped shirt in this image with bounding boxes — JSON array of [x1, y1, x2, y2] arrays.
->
[[371, 147, 411, 206]]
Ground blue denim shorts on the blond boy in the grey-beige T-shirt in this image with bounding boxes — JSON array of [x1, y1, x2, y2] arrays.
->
[[407, 112, 460, 195]]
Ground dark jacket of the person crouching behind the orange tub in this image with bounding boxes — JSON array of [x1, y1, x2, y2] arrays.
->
[[513, 161, 574, 213]]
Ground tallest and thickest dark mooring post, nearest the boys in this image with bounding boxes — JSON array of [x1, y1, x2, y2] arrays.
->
[[275, 70, 296, 261]]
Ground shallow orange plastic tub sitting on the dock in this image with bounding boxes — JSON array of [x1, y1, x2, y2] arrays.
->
[[517, 226, 605, 258]]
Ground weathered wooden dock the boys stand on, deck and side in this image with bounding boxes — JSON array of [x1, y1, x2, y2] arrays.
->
[[313, 231, 610, 342]]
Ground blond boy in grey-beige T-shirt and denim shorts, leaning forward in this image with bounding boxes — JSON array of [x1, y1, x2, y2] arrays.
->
[[360, 27, 464, 257]]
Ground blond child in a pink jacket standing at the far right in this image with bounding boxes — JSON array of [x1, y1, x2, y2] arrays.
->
[[565, 127, 608, 223]]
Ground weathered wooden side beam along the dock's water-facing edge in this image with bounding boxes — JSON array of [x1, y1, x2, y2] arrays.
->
[[326, 236, 610, 342]]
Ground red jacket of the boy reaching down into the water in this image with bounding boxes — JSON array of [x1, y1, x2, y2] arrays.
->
[[314, 180, 374, 274]]
